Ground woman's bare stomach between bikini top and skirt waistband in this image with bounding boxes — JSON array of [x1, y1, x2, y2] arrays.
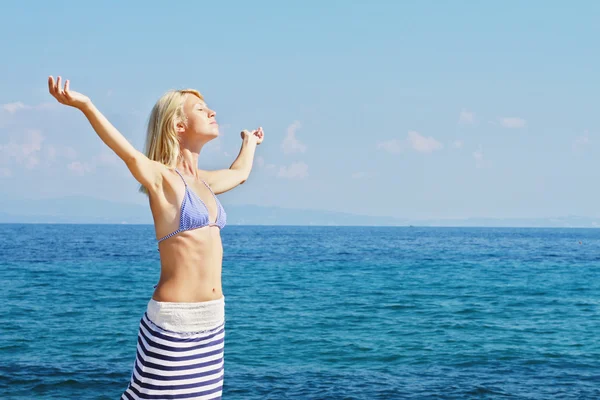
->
[[152, 226, 223, 303]]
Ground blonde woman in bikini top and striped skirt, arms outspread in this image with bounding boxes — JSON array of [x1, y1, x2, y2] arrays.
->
[[48, 76, 264, 400]]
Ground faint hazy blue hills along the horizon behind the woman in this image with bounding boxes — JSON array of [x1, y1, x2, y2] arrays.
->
[[0, 197, 600, 228]]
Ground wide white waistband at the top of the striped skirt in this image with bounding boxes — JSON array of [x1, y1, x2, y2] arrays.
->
[[146, 297, 225, 332]]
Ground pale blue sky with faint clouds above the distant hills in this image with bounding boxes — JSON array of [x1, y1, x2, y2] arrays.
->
[[0, 0, 600, 219]]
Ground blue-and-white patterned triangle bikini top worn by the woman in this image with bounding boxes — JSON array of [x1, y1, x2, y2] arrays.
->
[[158, 168, 227, 242]]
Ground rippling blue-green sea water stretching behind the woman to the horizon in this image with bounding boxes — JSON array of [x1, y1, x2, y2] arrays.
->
[[0, 225, 600, 399]]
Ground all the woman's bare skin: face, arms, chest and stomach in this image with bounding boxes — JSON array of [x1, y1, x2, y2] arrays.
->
[[48, 76, 264, 302]]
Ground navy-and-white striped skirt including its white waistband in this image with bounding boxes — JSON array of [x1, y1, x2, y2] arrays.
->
[[121, 298, 225, 400]]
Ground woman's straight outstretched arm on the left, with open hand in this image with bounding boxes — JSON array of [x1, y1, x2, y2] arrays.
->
[[48, 76, 166, 192]]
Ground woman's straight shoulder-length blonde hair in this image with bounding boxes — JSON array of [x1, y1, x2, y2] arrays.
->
[[139, 89, 204, 194]]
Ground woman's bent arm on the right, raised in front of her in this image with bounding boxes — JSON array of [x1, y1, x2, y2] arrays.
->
[[203, 128, 264, 194]]
